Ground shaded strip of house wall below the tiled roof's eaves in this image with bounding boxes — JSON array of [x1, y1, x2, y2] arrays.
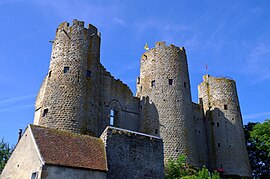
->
[[41, 165, 107, 179]]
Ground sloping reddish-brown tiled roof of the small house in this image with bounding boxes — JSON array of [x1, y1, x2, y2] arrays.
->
[[30, 125, 107, 171]]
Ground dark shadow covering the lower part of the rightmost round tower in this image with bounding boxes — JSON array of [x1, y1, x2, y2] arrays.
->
[[205, 108, 248, 177]]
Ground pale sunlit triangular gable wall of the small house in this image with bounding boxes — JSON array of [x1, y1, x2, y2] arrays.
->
[[1, 127, 42, 179]]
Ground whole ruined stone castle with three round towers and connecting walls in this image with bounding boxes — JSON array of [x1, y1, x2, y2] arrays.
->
[[1, 20, 251, 178]]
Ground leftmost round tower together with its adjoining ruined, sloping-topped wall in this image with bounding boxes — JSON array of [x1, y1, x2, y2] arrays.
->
[[34, 20, 140, 136]]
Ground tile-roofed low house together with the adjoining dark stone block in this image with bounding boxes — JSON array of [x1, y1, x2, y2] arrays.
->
[[0, 125, 164, 179]]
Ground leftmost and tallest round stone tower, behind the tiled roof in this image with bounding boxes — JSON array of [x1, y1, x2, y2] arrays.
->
[[34, 20, 100, 135]]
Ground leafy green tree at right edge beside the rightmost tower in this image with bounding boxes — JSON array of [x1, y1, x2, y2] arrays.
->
[[244, 120, 270, 178]]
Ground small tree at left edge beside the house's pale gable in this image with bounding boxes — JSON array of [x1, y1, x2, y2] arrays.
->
[[0, 139, 12, 173]]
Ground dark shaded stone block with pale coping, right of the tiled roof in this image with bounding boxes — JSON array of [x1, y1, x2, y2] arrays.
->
[[101, 127, 164, 179]]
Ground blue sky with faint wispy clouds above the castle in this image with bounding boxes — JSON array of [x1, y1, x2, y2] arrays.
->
[[0, 0, 270, 144]]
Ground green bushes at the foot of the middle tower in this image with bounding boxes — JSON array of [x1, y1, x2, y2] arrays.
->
[[165, 155, 220, 179]]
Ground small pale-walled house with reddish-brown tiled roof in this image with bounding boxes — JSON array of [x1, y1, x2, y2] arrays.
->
[[1, 125, 108, 179]]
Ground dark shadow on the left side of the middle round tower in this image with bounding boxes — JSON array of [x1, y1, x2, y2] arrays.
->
[[140, 96, 159, 136]]
